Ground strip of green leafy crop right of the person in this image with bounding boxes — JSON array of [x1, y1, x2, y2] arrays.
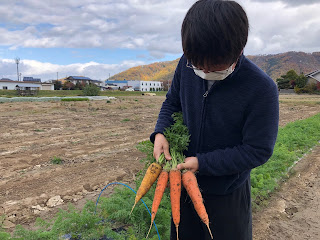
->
[[251, 114, 320, 208]]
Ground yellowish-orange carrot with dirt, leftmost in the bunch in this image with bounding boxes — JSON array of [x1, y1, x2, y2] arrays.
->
[[130, 163, 162, 214]]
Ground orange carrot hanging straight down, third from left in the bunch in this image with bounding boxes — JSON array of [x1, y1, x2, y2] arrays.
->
[[169, 168, 181, 240]]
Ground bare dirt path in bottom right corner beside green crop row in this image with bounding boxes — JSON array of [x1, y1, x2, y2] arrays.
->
[[253, 146, 320, 240]]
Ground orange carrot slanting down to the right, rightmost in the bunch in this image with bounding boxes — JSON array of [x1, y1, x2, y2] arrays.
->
[[182, 171, 213, 239]]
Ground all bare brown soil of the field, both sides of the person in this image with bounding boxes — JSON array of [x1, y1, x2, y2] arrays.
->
[[0, 95, 320, 240]]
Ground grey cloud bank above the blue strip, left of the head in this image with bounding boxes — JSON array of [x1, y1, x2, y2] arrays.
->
[[0, 0, 193, 57]]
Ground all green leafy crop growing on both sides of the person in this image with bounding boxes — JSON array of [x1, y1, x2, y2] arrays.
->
[[0, 114, 320, 240]]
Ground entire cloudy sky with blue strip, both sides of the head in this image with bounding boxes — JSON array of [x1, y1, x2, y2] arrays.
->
[[0, 0, 320, 81]]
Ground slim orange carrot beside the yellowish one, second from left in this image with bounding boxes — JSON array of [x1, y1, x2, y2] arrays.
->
[[146, 170, 169, 238]]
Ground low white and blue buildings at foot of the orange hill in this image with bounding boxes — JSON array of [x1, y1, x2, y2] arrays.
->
[[105, 80, 163, 92]]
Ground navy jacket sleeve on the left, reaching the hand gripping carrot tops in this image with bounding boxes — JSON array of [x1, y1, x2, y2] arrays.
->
[[150, 57, 183, 143]]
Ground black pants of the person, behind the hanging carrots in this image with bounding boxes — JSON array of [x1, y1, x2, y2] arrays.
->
[[170, 179, 252, 240]]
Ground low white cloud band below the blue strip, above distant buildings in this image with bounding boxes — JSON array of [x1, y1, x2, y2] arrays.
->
[[0, 59, 145, 81]]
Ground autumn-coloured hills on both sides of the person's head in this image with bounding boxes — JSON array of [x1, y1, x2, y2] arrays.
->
[[110, 52, 320, 82]]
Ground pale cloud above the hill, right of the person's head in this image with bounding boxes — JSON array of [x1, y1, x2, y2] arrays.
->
[[244, 0, 320, 54]]
